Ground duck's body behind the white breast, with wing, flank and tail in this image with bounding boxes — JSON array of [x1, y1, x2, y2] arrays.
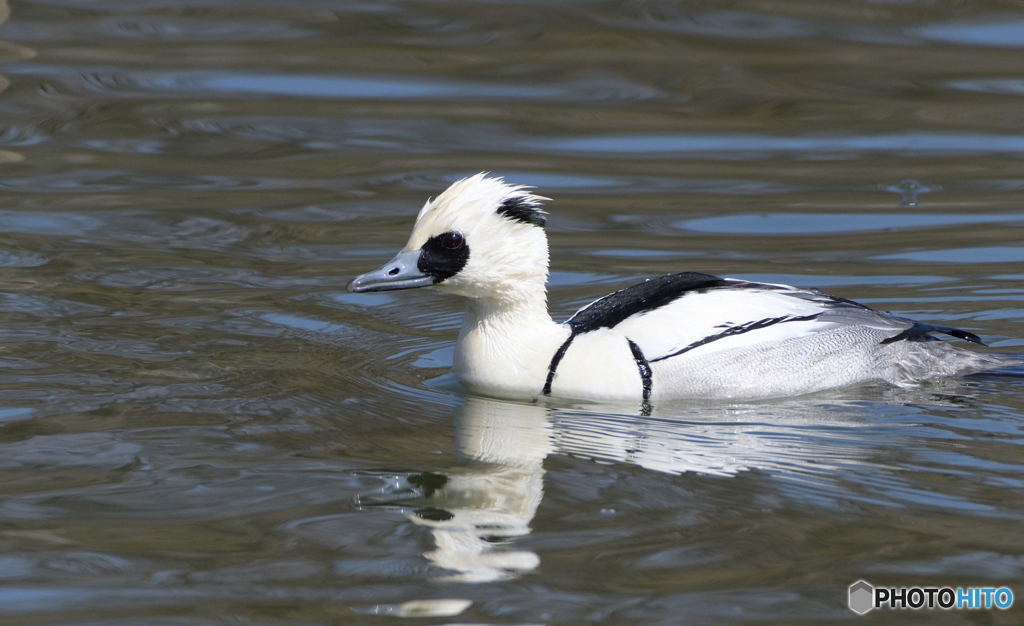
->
[[544, 273, 1001, 400]]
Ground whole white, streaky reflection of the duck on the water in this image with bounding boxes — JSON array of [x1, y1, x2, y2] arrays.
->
[[356, 368, 1024, 582]]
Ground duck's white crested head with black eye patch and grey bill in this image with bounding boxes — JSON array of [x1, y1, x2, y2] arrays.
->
[[348, 173, 548, 299]]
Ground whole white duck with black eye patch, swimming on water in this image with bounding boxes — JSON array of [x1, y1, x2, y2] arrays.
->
[[348, 173, 1021, 405]]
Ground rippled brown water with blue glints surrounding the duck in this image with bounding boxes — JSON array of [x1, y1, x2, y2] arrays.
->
[[0, 0, 1024, 624]]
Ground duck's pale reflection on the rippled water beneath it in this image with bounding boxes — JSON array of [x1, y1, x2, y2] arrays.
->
[[359, 390, 950, 582]]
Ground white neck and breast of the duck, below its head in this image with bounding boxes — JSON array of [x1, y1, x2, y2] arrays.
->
[[455, 289, 568, 398]]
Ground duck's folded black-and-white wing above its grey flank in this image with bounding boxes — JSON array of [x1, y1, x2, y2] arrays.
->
[[565, 273, 980, 363]]
